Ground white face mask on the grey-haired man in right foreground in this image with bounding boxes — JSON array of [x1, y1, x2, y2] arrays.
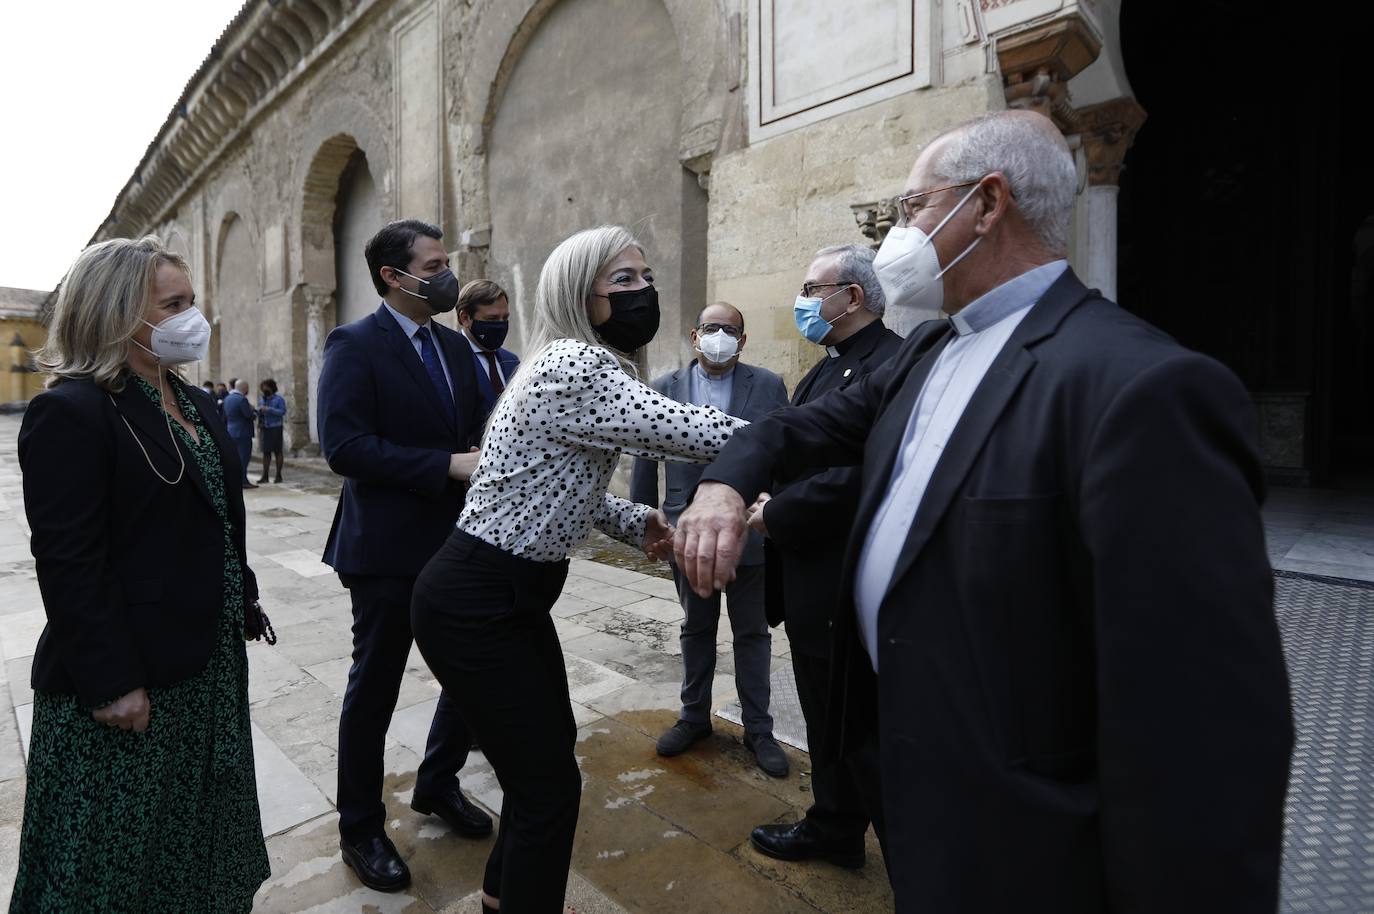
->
[[872, 178, 982, 337]]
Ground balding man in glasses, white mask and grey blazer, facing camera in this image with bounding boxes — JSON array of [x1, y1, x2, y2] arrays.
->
[[631, 302, 787, 778]]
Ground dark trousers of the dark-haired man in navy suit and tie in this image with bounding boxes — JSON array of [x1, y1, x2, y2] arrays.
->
[[338, 575, 473, 841]]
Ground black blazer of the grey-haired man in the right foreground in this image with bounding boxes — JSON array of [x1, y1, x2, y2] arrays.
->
[[706, 272, 1293, 914]]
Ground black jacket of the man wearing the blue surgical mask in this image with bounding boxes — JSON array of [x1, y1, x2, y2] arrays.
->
[[764, 320, 901, 657]]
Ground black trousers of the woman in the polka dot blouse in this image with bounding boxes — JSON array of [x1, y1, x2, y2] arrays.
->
[[411, 531, 583, 914]]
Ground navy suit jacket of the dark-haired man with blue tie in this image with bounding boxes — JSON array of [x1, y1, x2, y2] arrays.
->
[[317, 305, 482, 577]]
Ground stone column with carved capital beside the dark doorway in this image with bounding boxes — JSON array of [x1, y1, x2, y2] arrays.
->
[[1076, 96, 1145, 301]]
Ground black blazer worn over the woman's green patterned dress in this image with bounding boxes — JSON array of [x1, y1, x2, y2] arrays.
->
[[19, 381, 257, 706]]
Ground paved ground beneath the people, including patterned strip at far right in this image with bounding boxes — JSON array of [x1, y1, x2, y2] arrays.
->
[[0, 416, 1374, 914]]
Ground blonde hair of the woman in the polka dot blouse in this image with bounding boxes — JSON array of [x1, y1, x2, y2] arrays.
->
[[525, 225, 644, 377]]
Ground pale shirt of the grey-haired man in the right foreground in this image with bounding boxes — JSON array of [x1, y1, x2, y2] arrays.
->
[[855, 260, 1069, 672]]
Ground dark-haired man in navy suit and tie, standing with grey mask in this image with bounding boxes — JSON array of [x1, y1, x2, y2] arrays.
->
[[319, 219, 492, 892]]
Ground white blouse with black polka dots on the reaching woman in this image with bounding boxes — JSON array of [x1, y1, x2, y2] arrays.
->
[[458, 339, 749, 562]]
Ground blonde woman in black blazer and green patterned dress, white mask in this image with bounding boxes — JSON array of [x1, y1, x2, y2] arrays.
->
[[11, 238, 269, 911]]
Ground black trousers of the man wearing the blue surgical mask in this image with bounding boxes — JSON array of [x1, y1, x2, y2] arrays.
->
[[791, 649, 881, 841]]
